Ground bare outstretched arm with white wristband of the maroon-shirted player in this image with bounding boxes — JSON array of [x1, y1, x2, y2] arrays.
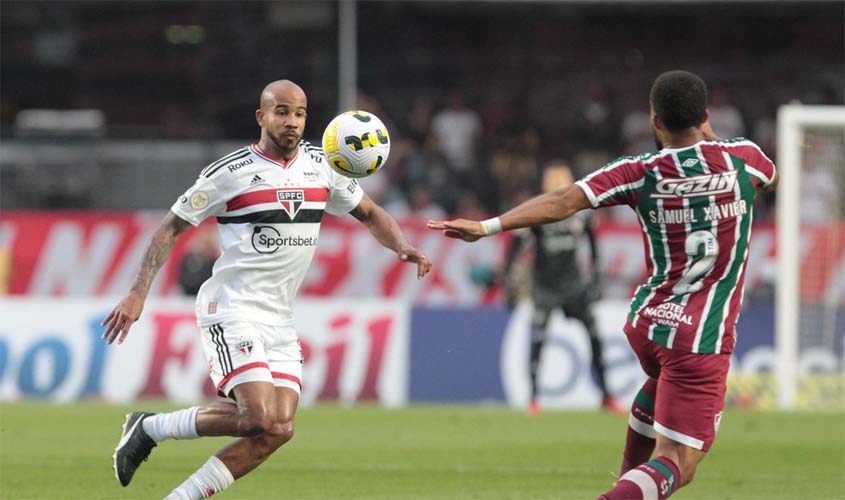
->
[[428, 185, 590, 241]]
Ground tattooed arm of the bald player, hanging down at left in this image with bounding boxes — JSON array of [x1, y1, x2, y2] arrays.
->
[[100, 212, 191, 344]]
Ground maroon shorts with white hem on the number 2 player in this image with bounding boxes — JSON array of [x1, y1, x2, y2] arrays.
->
[[628, 333, 730, 451]]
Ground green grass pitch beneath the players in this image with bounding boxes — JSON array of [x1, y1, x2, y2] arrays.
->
[[0, 403, 845, 500]]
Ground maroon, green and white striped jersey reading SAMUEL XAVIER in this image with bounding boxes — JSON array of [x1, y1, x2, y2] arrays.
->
[[576, 138, 775, 353]]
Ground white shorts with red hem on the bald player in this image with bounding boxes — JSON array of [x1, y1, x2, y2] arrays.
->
[[201, 321, 303, 398]]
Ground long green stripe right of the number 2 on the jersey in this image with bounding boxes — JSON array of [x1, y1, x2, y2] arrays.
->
[[698, 155, 754, 354]]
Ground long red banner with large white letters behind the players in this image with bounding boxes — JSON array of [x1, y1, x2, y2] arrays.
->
[[0, 211, 845, 305]]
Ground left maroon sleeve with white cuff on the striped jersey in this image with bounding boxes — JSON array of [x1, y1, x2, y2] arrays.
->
[[575, 156, 645, 208]]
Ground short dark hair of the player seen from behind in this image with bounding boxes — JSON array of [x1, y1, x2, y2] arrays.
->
[[650, 71, 707, 132]]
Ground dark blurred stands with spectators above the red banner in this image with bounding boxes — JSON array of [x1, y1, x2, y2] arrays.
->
[[0, 2, 845, 220]]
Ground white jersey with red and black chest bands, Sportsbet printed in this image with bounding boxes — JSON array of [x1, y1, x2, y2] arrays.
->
[[171, 141, 364, 326]]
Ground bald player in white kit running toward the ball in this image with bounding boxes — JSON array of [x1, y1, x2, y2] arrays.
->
[[102, 80, 431, 500]]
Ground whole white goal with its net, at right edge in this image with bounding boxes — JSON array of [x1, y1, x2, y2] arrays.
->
[[774, 105, 845, 410]]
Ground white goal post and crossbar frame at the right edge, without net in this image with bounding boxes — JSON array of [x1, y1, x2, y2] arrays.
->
[[775, 104, 845, 410]]
